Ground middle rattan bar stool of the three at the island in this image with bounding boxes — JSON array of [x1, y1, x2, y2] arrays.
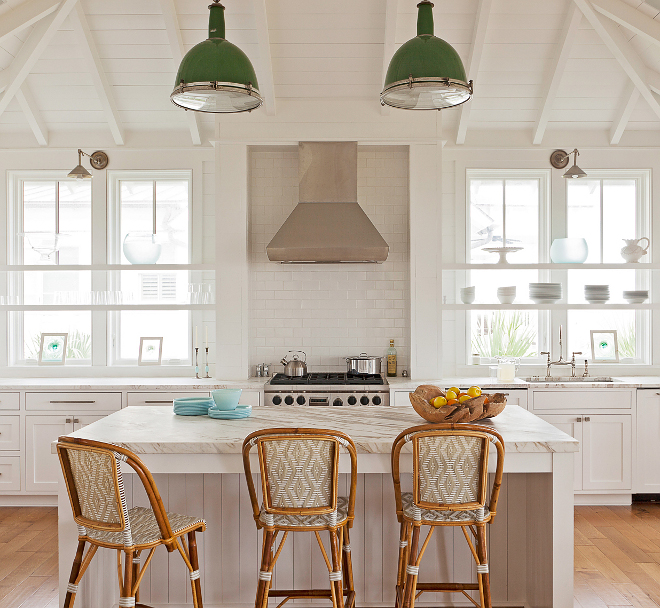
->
[[243, 429, 357, 608]]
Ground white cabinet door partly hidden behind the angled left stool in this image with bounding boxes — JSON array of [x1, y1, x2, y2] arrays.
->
[[25, 414, 73, 494]]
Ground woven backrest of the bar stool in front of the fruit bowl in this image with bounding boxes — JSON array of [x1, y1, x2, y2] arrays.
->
[[392, 424, 504, 512]]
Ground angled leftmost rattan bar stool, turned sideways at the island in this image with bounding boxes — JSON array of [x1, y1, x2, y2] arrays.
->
[[57, 437, 206, 608]]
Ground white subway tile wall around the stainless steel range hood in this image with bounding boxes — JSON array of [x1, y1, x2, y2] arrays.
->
[[248, 146, 410, 374]]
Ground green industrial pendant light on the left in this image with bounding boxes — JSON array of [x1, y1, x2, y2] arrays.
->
[[170, 0, 264, 113]]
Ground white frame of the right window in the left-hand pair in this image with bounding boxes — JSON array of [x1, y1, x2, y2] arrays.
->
[[107, 169, 195, 367]]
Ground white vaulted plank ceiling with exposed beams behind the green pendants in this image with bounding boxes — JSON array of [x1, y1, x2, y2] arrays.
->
[[0, 0, 660, 147]]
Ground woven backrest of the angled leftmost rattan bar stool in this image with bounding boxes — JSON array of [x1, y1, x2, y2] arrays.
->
[[57, 437, 172, 546]]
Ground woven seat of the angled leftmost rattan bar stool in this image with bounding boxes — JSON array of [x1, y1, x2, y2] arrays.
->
[[87, 507, 206, 547]]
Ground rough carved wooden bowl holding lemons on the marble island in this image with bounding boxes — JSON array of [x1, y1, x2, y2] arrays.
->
[[409, 384, 506, 423]]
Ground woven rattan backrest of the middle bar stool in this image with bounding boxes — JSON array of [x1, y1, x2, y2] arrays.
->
[[243, 429, 357, 518]]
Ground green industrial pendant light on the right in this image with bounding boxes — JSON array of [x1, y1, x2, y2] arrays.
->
[[380, 0, 472, 110]]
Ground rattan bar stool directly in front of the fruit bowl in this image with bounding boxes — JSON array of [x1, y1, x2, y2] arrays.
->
[[392, 424, 504, 608]]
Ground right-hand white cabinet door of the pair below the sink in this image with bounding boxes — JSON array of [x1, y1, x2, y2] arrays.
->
[[582, 414, 632, 491]]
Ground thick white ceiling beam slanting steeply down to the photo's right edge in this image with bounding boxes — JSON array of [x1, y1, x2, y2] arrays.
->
[[574, 0, 660, 118]]
